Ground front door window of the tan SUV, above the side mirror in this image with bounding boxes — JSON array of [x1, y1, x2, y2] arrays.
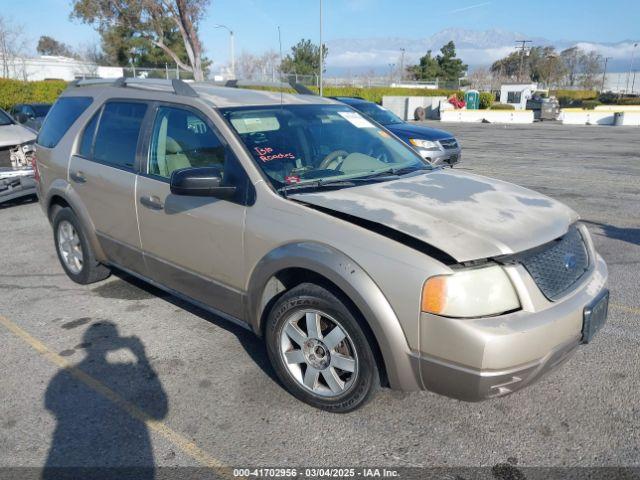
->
[[149, 107, 225, 178]]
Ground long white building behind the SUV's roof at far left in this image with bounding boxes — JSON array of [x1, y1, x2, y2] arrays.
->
[[0, 55, 124, 81]]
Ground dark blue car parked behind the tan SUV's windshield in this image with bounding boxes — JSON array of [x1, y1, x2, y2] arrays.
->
[[332, 97, 462, 165]]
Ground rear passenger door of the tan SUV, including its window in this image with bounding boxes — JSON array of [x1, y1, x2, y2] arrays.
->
[[69, 100, 148, 274]]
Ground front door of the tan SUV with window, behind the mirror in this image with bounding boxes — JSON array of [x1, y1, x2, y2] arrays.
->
[[136, 106, 247, 318]]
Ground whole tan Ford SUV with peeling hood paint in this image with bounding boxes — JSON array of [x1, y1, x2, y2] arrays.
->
[[36, 80, 608, 412]]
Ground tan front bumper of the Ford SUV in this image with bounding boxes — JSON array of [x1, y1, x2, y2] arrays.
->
[[418, 256, 607, 401]]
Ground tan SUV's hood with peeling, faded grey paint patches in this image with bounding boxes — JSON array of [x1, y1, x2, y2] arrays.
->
[[289, 170, 578, 262]]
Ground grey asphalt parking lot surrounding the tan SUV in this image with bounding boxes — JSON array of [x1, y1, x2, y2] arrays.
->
[[0, 123, 640, 474]]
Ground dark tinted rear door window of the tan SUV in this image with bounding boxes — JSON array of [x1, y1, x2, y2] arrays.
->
[[93, 102, 147, 169]]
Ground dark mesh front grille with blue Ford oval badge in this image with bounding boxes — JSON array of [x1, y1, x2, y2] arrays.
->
[[519, 227, 589, 300]]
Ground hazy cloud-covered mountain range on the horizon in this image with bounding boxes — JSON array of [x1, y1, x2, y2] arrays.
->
[[327, 28, 640, 75]]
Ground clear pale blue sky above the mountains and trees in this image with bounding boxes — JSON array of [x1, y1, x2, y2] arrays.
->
[[5, 0, 640, 71]]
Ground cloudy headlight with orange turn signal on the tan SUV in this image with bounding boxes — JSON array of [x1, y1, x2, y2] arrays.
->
[[422, 265, 520, 318]]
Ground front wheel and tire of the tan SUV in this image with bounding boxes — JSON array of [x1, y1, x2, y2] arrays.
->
[[265, 283, 380, 413]]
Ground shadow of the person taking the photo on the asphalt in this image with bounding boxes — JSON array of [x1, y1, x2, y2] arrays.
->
[[42, 321, 168, 480]]
